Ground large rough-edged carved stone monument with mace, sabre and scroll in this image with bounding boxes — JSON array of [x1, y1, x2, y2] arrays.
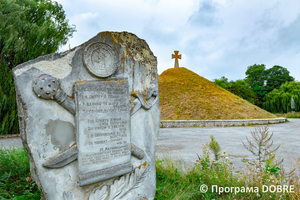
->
[[13, 32, 160, 200]]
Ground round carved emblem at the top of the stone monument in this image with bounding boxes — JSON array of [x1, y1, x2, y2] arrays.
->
[[82, 42, 117, 78]]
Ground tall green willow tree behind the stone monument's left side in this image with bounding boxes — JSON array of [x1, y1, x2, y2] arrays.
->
[[0, 0, 75, 135]]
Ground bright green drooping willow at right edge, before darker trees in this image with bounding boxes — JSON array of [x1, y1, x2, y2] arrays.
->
[[263, 81, 300, 113]]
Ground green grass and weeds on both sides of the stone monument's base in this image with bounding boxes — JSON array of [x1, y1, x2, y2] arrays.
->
[[0, 146, 300, 200]]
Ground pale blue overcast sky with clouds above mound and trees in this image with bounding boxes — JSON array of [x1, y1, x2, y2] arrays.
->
[[57, 0, 300, 80]]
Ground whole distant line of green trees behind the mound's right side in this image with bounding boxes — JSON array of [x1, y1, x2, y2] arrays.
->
[[214, 64, 300, 113]]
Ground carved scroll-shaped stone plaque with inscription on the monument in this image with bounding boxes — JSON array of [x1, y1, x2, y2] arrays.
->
[[74, 79, 132, 186]]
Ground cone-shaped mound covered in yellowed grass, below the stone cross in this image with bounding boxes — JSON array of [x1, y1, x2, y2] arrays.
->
[[158, 67, 276, 120]]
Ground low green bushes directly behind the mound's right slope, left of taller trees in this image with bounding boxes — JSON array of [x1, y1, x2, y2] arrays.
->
[[214, 76, 261, 106]]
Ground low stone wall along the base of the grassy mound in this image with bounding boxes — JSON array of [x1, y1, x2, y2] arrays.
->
[[160, 118, 287, 128]]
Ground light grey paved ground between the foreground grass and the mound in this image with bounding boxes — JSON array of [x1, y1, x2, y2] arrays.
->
[[0, 119, 300, 172]]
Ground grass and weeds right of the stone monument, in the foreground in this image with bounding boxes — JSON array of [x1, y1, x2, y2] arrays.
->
[[155, 150, 300, 200]]
